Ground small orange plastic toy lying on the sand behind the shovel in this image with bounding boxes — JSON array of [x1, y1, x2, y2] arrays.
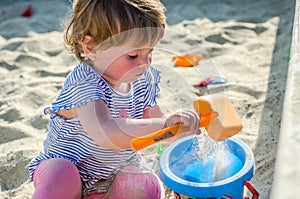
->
[[172, 54, 202, 67]]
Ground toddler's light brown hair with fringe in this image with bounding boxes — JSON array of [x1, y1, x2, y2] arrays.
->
[[64, 0, 166, 61]]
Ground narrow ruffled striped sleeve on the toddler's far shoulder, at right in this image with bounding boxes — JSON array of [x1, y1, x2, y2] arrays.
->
[[144, 67, 160, 108]]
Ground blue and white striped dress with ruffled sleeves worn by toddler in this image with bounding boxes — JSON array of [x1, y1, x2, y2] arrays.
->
[[29, 63, 160, 195]]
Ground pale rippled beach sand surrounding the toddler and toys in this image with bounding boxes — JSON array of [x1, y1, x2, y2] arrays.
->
[[0, 0, 294, 199]]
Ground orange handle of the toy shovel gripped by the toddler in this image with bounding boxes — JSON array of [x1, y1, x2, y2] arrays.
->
[[131, 112, 218, 151]]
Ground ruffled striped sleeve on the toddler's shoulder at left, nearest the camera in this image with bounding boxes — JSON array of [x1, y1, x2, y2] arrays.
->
[[51, 63, 108, 112]]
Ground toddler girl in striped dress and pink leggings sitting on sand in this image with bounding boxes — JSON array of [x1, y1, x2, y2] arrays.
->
[[29, 0, 199, 199]]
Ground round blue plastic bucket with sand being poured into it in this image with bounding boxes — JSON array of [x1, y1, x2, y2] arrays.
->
[[159, 135, 258, 199]]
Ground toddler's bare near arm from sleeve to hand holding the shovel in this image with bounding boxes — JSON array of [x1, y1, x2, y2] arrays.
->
[[76, 100, 199, 149]]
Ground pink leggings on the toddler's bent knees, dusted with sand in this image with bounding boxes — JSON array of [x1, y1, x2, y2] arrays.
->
[[32, 158, 164, 199]]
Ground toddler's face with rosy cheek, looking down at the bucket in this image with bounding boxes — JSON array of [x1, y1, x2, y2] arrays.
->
[[90, 45, 153, 85]]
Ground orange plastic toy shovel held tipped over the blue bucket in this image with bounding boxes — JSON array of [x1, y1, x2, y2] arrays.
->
[[131, 94, 243, 151]]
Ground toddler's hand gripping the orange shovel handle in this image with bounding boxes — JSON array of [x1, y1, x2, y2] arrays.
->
[[164, 110, 200, 134]]
